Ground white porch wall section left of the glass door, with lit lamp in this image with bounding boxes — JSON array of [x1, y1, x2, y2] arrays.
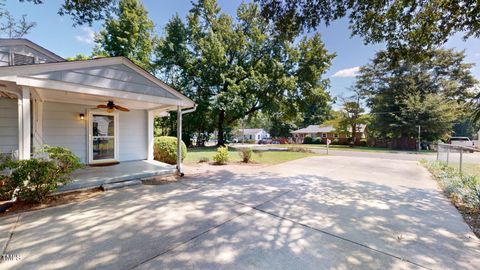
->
[[43, 102, 89, 163]]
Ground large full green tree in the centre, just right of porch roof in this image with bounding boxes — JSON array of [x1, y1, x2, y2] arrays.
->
[[157, 0, 334, 145]]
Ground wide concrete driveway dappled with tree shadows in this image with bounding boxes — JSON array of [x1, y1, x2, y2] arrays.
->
[[0, 156, 480, 269]]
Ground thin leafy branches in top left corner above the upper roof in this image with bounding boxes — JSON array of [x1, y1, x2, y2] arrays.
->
[[0, 0, 37, 38]]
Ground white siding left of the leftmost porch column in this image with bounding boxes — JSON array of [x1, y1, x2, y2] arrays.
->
[[0, 98, 18, 153]]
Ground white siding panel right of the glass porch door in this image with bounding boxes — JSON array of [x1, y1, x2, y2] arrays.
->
[[118, 110, 148, 161]]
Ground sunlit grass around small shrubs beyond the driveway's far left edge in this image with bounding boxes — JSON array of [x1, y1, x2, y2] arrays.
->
[[185, 147, 316, 164]]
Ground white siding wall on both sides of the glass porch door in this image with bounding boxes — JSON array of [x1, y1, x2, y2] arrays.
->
[[43, 102, 147, 163]]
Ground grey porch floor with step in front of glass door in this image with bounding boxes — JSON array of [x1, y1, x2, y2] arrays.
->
[[58, 160, 176, 192]]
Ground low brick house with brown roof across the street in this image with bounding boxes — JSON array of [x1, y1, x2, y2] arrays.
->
[[291, 124, 366, 143]]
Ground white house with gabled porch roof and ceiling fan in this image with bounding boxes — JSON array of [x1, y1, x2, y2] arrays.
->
[[0, 39, 195, 169]]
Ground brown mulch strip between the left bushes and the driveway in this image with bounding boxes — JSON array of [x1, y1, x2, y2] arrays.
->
[[0, 188, 103, 216]]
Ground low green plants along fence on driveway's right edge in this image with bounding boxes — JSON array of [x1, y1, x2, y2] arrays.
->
[[422, 160, 480, 211]]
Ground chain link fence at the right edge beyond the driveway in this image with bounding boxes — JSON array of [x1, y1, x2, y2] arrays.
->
[[437, 143, 480, 172]]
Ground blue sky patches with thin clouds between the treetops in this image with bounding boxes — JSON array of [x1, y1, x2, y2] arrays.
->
[[3, 0, 480, 102]]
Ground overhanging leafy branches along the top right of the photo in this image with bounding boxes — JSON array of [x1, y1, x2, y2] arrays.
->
[[257, 0, 480, 52]]
